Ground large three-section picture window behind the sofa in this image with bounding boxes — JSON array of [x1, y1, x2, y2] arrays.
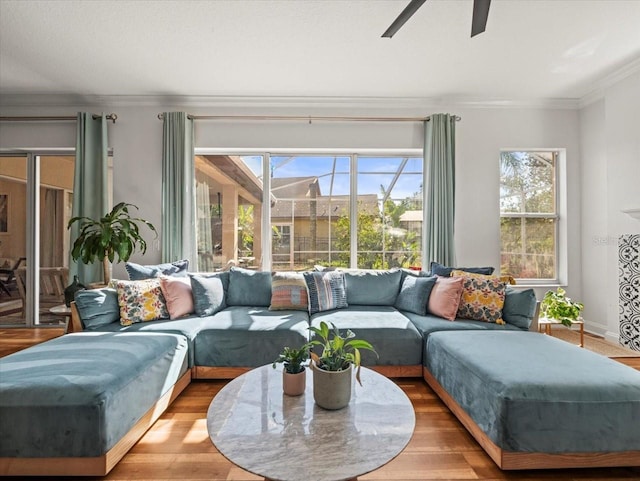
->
[[195, 153, 423, 271]]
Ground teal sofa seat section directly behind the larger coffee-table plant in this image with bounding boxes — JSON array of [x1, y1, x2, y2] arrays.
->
[[311, 306, 423, 366]]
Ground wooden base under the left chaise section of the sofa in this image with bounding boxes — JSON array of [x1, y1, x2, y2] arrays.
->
[[0, 371, 191, 476]]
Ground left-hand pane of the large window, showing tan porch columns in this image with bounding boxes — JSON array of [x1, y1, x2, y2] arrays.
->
[[195, 155, 263, 272]]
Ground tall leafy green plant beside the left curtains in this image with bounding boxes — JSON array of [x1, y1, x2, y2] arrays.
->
[[67, 202, 158, 284]]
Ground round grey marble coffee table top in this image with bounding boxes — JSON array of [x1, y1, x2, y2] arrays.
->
[[207, 365, 415, 481]]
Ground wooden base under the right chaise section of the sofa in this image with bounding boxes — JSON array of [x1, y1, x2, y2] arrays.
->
[[423, 368, 640, 470]]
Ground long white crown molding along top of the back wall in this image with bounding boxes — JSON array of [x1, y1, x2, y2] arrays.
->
[[0, 94, 579, 112]]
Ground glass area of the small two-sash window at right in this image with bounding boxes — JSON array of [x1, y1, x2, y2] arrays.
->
[[500, 151, 558, 281]]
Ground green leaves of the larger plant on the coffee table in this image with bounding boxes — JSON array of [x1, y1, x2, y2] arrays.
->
[[309, 321, 378, 385]]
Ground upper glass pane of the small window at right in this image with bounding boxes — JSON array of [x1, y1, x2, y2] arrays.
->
[[500, 152, 556, 214]]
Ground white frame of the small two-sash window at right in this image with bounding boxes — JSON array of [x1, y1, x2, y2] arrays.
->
[[498, 147, 568, 287]]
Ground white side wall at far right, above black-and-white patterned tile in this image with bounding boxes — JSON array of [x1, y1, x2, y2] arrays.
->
[[580, 69, 640, 342]]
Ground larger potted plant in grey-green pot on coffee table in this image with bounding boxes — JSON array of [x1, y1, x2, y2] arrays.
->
[[309, 321, 378, 409]]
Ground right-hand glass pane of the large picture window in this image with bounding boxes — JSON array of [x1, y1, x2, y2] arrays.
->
[[357, 157, 422, 269]]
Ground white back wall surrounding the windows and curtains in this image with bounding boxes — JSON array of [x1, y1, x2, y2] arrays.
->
[[0, 100, 582, 288]]
